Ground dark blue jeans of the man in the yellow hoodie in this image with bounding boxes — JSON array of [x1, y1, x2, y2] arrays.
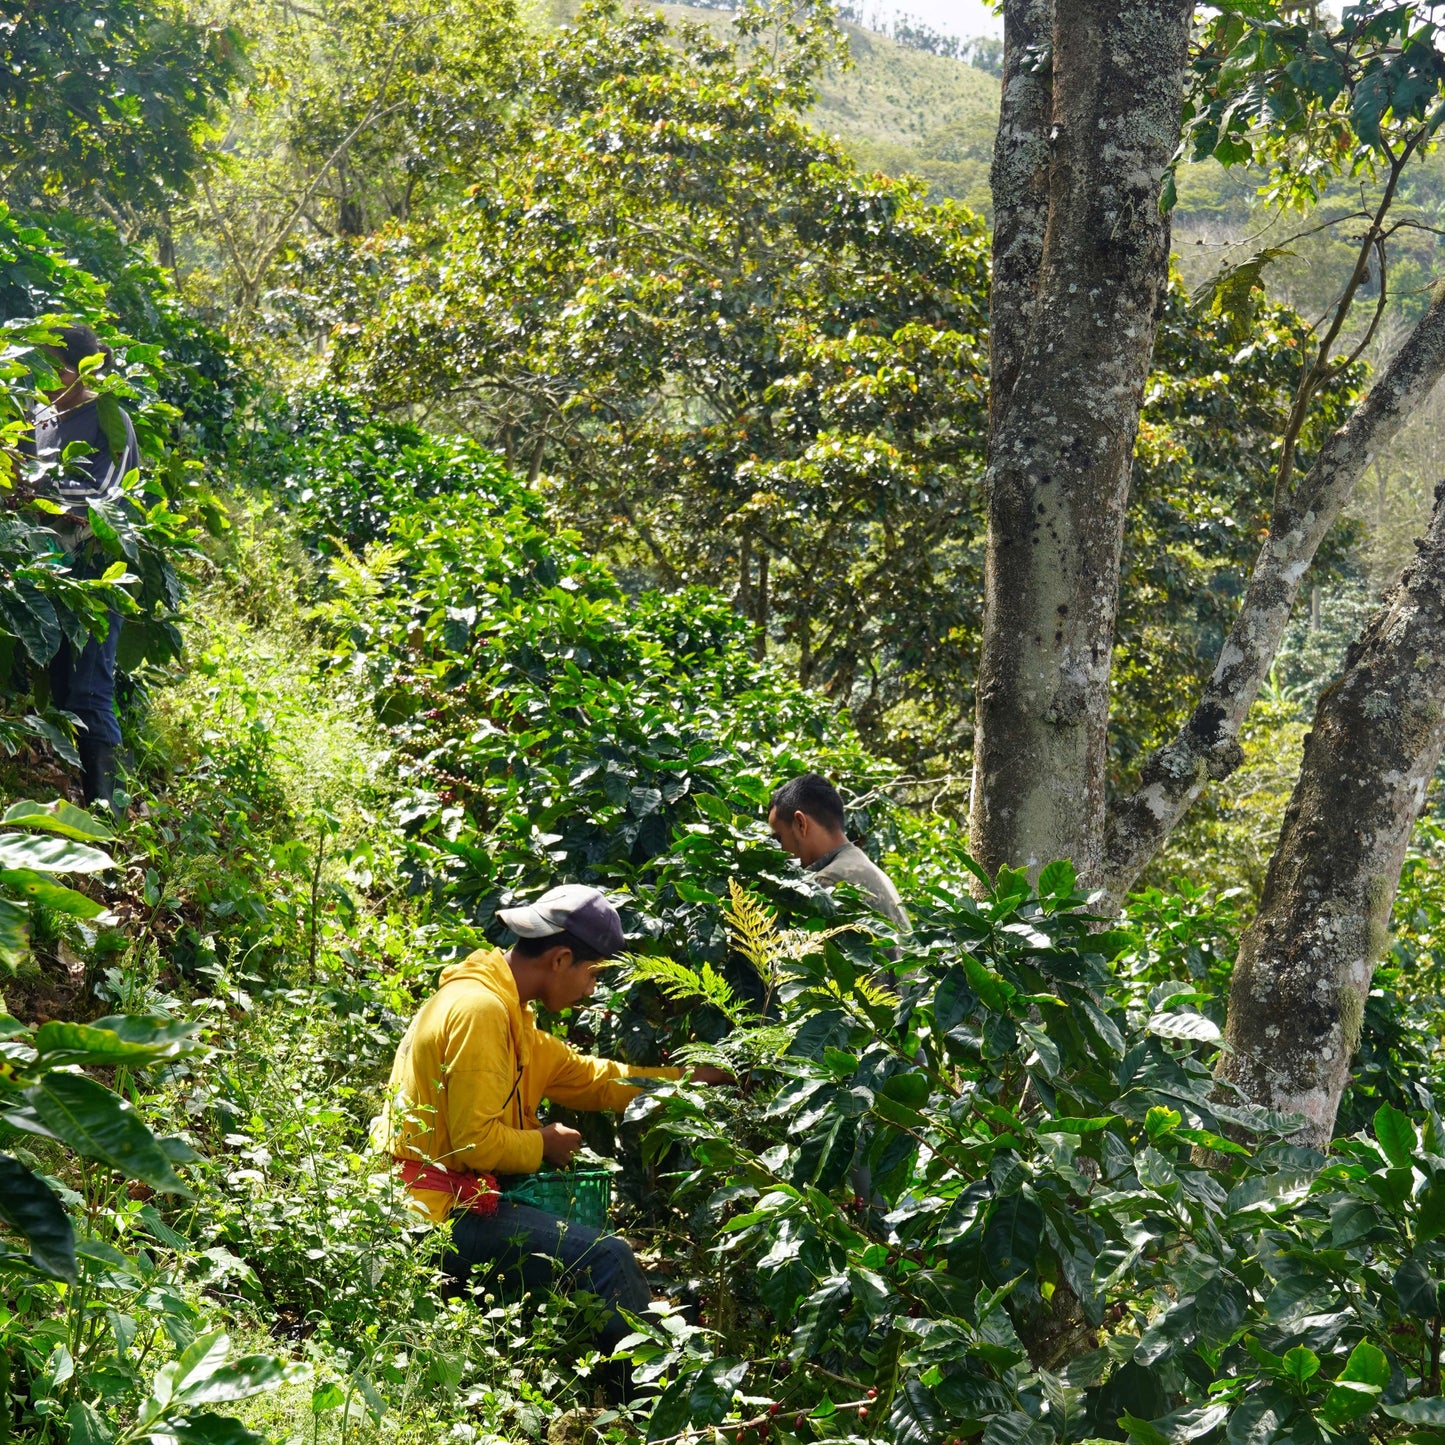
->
[[442, 1196, 652, 1350]]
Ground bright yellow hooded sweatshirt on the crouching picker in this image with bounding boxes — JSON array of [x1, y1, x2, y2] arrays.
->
[[387, 948, 682, 1224]]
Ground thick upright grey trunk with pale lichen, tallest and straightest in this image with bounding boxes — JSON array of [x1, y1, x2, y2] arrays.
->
[[971, 0, 1192, 881]]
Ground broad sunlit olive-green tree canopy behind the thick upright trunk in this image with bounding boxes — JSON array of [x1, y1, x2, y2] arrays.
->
[[270, 7, 1361, 796]]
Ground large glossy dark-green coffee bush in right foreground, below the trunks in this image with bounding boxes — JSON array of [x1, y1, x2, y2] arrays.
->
[[615, 864, 1445, 1445]]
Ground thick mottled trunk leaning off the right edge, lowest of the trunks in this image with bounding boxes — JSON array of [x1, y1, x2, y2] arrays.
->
[[1220, 484, 1445, 1146]]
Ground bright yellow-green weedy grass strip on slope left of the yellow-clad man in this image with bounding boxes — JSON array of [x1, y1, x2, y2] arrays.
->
[[98, 491, 621, 1445]]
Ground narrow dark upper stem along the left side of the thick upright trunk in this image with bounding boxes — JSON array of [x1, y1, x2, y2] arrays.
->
[[988, 0, 1053, 432]]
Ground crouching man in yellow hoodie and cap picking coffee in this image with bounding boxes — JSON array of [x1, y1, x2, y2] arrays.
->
[[389, 884, 724, 1347]]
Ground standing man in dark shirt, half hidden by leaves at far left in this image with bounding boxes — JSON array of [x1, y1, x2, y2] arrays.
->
[[33, 327, 140, 805]]
